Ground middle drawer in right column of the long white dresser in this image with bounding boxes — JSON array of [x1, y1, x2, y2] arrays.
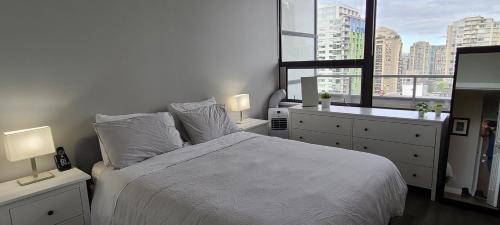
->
[[352, 137, 434, 167]]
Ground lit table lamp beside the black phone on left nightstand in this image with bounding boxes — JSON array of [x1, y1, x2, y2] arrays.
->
[[4, 126, 55, 186]]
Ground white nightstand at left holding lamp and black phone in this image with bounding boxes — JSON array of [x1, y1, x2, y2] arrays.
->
[[0, 168, 90, 225]]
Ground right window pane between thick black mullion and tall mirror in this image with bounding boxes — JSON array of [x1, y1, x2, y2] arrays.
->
[[373, 0, 500, 110]]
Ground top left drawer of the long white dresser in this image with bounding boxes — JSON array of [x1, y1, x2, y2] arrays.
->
[[291, 113, 352, 135]]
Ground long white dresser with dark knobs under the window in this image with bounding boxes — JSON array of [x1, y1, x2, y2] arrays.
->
[[289, 106, 449, 200]]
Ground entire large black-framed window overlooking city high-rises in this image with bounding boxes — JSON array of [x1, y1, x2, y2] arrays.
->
[[280, 0, 500, 109]]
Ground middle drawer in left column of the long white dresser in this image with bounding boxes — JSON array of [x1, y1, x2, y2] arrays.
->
[[290, 129, 351, 149]]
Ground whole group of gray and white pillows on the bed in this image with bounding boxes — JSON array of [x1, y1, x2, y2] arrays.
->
[[94, 97, 240, 169]]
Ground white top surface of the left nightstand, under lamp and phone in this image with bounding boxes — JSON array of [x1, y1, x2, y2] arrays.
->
[[0, 168, 90, 207]]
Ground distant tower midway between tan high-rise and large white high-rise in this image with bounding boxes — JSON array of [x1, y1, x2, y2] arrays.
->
[[406, 41, 431, 75]]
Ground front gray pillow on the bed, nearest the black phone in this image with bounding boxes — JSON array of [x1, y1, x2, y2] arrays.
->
[[94, 113, 183, 169]]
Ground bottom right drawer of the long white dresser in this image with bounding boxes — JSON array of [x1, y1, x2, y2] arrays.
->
[[394, 163, 432, 188]]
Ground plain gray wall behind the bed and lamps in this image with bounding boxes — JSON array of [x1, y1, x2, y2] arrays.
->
[[0, 0, 278, 181]]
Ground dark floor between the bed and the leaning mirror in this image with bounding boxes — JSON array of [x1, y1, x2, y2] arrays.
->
[[391, 189, 500, 225]]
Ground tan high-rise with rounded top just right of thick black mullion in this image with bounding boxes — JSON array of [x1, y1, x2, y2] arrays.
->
[[373, 27, 403, 95]]
